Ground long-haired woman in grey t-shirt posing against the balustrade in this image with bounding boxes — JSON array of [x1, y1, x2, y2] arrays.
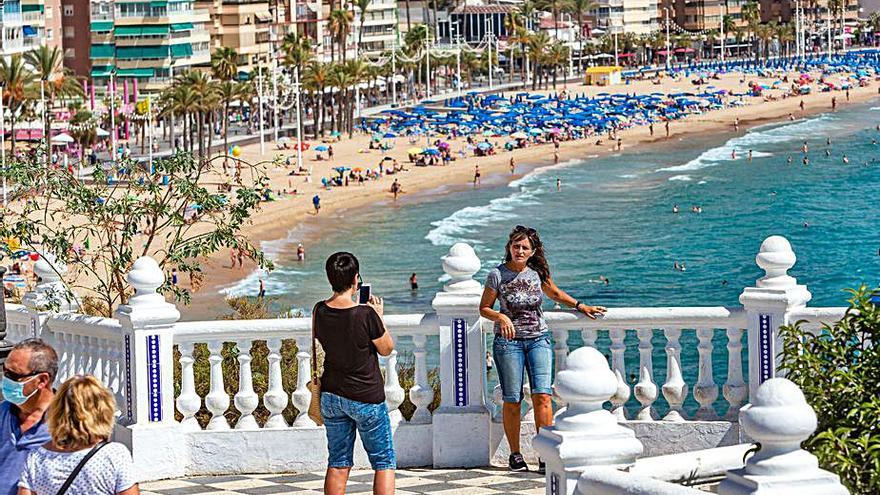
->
[[480, 225, 605, 472]]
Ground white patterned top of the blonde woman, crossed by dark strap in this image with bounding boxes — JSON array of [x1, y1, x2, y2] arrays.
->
[[18, 442, 136, 495]]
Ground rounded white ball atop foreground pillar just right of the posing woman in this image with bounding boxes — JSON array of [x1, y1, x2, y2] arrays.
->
[[554, 347, 617, 409]]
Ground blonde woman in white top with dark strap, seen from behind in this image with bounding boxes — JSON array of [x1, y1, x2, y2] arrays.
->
[[18, 375, 140, 495]]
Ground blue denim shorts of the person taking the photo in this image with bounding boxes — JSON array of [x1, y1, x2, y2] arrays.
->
[[321, 392, 397, 471]]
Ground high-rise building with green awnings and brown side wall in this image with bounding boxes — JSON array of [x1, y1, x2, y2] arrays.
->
[[62, 0, 210, 89]]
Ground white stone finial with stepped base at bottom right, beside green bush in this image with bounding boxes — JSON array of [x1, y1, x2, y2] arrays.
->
[[718, 378, 849, 495]]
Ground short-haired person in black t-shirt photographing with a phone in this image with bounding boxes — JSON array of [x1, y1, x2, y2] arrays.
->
[[312, 252, 397, 495]]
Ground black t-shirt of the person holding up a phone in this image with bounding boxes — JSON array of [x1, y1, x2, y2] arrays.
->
[[315, 301, 385, 404]]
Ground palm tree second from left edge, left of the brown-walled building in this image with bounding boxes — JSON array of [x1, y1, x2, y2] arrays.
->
[[24, 45, 84, 166]]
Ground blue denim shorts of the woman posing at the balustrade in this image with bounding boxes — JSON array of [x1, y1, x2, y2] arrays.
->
[[492, 332, 553, 404]]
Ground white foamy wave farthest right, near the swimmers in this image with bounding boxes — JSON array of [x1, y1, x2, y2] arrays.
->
[[655, 115, 834, 172]]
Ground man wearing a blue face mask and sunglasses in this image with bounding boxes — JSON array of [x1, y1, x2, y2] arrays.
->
[[0, 339, 58, 495]]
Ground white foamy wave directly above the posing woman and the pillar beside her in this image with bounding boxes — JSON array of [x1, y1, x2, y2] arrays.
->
[[425, 189, 538, 246]]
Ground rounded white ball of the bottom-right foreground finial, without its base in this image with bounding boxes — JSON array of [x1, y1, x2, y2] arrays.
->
[[739, 378, 816, 450]]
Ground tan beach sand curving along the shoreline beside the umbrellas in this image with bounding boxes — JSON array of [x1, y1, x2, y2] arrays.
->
[[89, 74, 878, 320]]
